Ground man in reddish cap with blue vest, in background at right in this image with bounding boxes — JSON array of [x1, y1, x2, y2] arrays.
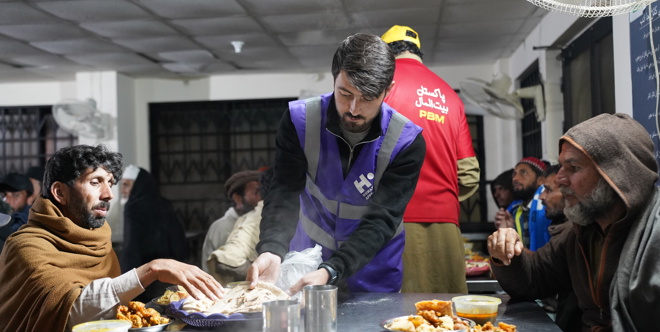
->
[[495, 157, 550, 251]]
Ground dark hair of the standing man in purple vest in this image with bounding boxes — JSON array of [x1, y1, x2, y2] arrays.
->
[[332, 33, 394, 99]]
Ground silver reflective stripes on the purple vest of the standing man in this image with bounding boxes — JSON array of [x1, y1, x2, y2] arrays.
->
[[299, 97, 408, 250]]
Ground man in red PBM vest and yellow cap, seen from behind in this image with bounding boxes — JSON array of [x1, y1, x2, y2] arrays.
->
[[382, 25, 480, 293]]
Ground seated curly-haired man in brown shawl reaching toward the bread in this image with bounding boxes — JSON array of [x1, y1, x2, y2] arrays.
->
[[0, 145, 223, 332]]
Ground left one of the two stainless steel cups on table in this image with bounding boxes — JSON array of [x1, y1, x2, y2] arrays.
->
[[262, 300, 300, 332]]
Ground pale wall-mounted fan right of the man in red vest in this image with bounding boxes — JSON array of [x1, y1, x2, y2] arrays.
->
[[459, 73, 545, 122]]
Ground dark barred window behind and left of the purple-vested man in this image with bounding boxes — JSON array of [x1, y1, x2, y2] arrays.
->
[[149, 98, 293, 232]]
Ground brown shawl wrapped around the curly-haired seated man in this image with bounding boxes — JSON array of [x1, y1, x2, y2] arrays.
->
[[0, 197, 120, 332]]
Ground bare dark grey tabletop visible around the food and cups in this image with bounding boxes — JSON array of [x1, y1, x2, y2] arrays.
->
[[167, 293, 561, 332]]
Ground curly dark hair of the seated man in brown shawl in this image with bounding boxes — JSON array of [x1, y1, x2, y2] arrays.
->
[[41, 144, 123, 199]]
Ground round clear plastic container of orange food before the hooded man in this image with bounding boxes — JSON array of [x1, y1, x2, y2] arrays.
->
[[451, 295, 502, 325]]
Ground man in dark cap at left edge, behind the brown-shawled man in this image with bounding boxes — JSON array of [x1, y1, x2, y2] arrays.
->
[[0, 173, 33, 251]]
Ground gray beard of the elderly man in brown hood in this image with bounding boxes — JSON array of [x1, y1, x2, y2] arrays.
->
[[562, 178, 617, 226]]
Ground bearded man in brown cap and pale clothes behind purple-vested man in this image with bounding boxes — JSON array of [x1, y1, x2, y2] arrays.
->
[[201, 170, 261, 274]]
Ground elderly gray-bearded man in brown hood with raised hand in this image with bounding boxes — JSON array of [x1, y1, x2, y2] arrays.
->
[[488, 114, 660, 331]]
